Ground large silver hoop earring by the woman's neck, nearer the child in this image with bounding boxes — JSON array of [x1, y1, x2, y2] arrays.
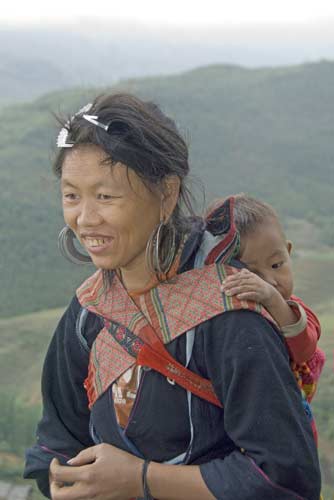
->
[[146, 222, 176, 275]]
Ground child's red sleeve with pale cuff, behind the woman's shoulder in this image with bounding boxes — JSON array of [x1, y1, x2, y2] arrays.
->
[[281, 295, 321, 363]]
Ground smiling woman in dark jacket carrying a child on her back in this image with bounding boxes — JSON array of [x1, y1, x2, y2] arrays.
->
[[25, 95, 320, 500]]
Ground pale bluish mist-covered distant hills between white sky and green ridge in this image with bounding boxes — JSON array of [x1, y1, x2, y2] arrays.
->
[[0, 18, 334, 105]]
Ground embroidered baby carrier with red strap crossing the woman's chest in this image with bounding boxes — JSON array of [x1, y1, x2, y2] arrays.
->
[[77, 197, 318, 438]]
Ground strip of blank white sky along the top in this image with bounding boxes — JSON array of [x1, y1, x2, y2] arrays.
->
[[0, 0, 334, 26]]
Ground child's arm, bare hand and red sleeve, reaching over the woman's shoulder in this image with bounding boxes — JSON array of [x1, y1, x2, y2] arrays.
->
[[222, 269, 320, 363]]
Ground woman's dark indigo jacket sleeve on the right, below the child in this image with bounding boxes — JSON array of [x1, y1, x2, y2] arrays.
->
[[200, 311, 320, 500]]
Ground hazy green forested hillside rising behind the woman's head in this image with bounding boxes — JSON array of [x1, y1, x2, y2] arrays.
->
[[0, 62, 334, 317]]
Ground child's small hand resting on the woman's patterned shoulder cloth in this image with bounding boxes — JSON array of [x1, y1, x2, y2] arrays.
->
[[221, 268, 279, 307]]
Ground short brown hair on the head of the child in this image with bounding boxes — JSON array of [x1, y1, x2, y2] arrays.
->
[[233, 193, 284, 237]]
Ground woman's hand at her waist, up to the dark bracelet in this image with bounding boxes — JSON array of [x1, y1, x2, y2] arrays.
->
[[49, 444, 143, 500]]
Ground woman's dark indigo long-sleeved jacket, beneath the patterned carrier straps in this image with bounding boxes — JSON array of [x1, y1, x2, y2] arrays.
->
[[24, 229, 320, 500]]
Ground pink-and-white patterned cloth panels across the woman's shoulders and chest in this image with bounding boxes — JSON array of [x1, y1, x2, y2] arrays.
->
[[77, 264, 272, 406]]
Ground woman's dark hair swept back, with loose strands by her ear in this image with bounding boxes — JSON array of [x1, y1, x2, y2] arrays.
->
[[53, 93, 195, 282]]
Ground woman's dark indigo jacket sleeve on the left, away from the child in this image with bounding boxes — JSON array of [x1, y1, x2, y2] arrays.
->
[[24, 297, 100, 497]]
